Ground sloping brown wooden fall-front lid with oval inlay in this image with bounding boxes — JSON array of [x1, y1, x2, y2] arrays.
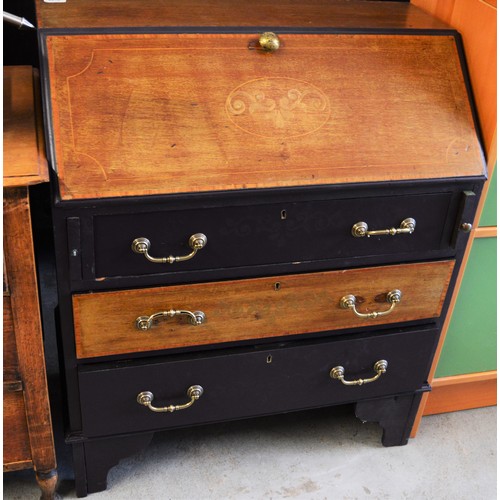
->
[[47, 35, 484, 199]]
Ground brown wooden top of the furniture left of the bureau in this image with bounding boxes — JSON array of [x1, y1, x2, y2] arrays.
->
[[3, 66, 48, 186]]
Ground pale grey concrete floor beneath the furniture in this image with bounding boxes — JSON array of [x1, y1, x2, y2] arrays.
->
[[3, 407, 497, 500]]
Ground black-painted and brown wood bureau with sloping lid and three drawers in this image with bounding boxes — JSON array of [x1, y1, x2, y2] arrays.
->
[[37, 0, 485, 496]]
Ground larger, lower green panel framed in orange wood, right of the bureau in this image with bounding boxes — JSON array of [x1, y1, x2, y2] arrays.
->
[[435, 238, 497, 377]]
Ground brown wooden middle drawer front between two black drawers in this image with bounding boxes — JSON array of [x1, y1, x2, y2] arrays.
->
[[73, 261, 454, 358]]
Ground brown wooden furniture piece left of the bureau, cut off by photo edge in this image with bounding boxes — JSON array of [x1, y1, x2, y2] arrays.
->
[[3, 66, 57, 498]]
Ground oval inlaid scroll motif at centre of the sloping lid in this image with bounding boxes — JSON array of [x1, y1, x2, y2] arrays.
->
[[226, 77, 330, 138]]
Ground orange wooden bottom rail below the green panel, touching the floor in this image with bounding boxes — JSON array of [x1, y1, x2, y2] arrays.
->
[[424, 370, 497, 416]]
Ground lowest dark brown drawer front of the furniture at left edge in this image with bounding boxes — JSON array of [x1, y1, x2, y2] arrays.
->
[[3, 392, 32, 470]]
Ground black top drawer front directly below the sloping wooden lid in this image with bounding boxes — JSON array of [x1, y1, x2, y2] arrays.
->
[[93, 192, 461, 279]]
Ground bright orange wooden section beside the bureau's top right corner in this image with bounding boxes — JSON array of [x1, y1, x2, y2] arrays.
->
[[411, 0, 497, 152]]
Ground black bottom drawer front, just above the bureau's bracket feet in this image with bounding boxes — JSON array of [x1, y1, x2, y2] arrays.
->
[[79, 328, 438, 437]]
